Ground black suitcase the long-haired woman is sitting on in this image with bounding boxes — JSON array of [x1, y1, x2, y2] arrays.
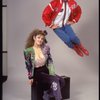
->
[[31, 76, 70, 100]]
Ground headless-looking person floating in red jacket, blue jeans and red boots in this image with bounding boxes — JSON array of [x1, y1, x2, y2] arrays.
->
[[42, 0, 89, 57]]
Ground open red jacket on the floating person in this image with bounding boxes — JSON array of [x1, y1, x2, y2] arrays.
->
[[42, 0, 82, 26]]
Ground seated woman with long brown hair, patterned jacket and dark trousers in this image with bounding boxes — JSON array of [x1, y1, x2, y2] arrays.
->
[[24, 29, 65, 100]]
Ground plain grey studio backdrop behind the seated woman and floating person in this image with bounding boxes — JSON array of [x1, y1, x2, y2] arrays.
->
[[3, 0, 99, 100]]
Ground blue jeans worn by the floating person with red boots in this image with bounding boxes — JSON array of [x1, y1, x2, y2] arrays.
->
[[53, 25, 80, 48]]
